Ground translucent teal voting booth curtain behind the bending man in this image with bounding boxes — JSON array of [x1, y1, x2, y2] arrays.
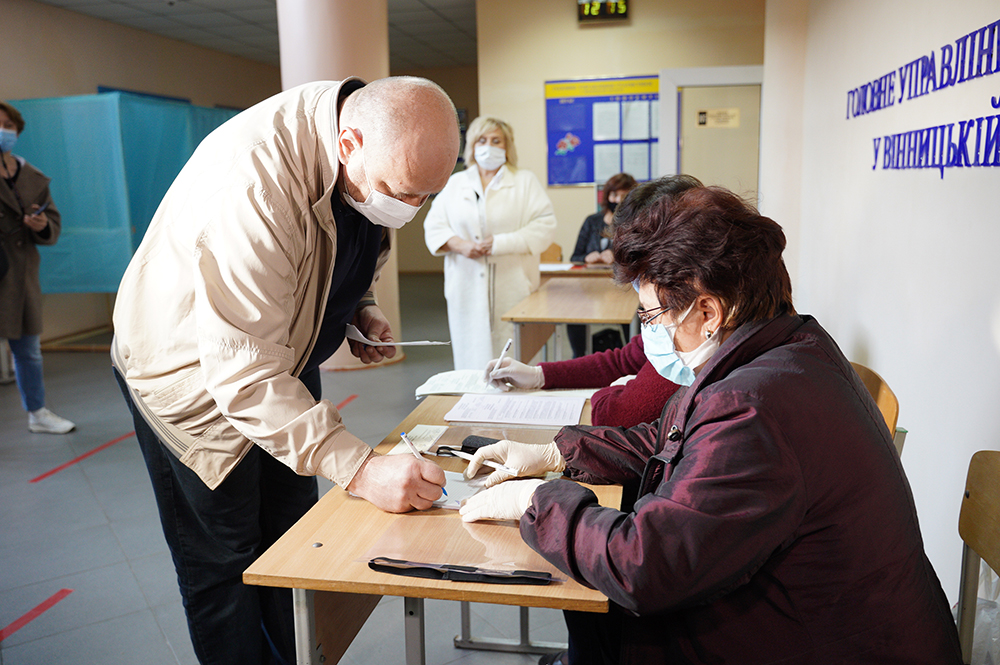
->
[[11, 92, 237, 293]]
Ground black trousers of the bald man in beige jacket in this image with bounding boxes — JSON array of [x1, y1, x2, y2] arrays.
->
[[115, 370, 319, 665]]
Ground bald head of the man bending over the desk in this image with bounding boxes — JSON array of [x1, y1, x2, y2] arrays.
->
[[339, 76, 459, 202]]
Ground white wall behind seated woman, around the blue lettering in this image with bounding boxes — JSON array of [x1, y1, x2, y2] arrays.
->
[[761, 0, 1000, 602]]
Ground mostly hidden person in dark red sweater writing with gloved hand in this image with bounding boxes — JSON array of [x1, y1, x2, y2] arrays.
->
[[485, 174, 702, 427]]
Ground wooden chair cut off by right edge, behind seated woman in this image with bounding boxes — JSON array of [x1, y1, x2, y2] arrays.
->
[[958, 450, 1000, 665]]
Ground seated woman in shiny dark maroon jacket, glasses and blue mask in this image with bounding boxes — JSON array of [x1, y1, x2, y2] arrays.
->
[[461, 187, 961, 665]]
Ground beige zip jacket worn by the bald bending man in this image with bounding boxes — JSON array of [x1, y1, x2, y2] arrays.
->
[[112, 80, 388, 489]]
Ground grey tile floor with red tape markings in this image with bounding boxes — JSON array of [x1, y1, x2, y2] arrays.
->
[[0, 275, 569, 665]]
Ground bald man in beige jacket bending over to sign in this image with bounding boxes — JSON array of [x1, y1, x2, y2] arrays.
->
[[112, 77, 459, 665]]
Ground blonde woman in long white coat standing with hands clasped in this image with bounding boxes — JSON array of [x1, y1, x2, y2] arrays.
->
[[424, 116, 556, 369]]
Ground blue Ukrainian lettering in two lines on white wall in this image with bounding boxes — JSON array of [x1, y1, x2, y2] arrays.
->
[[847, 20, 1000, 178]]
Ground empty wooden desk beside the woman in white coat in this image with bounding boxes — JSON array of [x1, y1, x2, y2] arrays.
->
[[502, 277, 639, 363]]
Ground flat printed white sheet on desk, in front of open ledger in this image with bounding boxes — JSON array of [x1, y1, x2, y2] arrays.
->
[[444, 393, 587, 427]]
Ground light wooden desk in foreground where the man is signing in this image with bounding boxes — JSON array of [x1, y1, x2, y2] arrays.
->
[[243, 395, 621, 665]]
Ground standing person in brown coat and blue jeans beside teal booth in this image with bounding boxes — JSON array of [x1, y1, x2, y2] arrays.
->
[[0, 97, 76, 434]]
